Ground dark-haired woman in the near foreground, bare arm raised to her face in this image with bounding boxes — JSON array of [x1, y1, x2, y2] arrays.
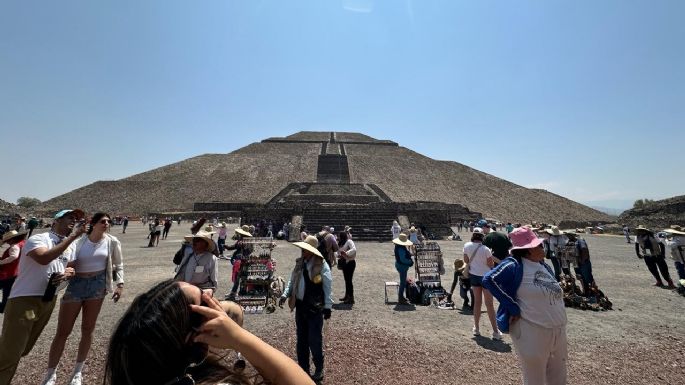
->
[[104, 280, 313, 385]]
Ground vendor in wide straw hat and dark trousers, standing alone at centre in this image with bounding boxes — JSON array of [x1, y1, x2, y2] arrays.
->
[[278, 236, 333, 382]]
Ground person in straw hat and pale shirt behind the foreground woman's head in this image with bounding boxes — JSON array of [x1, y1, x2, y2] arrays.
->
[[174, 231, 219, 295]]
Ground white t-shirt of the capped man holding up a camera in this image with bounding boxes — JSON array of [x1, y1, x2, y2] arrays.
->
[[10, 231, 75, 298]]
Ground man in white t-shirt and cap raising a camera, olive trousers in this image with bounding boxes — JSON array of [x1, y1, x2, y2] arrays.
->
[[0, 209, 86, 385]]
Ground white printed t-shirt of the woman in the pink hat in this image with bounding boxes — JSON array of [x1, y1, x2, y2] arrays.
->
[[516, 258, 566, 328]]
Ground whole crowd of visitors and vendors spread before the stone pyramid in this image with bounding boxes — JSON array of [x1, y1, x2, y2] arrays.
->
[[0, 209, 685, 385]]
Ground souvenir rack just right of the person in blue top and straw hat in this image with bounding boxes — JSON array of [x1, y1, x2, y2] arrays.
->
[[414, 242, 447, 306]]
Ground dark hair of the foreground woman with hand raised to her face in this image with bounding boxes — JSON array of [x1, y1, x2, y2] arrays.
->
[[103, 280, 251, 385]]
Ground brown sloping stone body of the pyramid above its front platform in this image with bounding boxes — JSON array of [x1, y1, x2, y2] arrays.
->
[[44, 132, 611, 223]]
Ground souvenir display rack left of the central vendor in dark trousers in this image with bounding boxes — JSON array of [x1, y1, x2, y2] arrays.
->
[[236, 237, 282, 314]]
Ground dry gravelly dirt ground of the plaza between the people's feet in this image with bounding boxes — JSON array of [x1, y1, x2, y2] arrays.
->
[[2, 223, 685, 385]]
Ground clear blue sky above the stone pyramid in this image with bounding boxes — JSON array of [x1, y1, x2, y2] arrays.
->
[[0, 0, 685, 208]]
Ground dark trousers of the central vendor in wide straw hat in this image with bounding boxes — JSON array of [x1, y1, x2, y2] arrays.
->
[[295, 301, 323, 374]]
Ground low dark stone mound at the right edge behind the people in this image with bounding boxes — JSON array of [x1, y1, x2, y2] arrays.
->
[[618, 195, 685, 228]]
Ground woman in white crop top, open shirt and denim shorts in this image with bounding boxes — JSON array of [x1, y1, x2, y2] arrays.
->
[[43, 213, 124, 385]]
